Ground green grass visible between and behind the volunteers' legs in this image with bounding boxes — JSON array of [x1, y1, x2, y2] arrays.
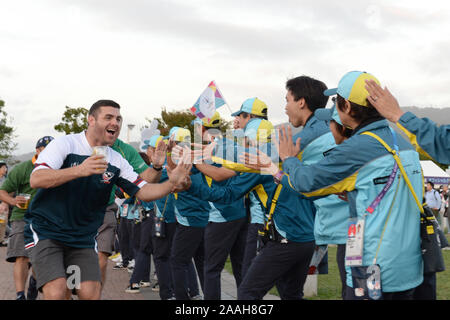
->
[[225, 234, 450, 300]]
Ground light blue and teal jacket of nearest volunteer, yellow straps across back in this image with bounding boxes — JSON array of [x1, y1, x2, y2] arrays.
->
[[282, 120, 423, 292]]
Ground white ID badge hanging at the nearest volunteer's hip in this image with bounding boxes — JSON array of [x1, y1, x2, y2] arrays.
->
[[345, 218, 365, 266]]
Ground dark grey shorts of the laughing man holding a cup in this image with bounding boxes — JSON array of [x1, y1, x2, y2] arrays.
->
[[29, 239, 101, 290]]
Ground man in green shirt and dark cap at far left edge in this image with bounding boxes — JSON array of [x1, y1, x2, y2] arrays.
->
[[0, 136, 53, 300]]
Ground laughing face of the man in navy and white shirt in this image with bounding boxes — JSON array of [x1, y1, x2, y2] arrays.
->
[[87, 106, 122, 146]]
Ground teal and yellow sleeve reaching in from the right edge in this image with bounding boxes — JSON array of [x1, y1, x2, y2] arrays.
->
[[397, 112, 450, 164]]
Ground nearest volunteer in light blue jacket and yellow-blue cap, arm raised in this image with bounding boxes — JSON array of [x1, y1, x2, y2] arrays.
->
[[277, 71, 423, 299]]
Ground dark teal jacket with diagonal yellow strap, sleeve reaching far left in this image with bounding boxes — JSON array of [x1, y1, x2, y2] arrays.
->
[[188, 173, 315, 242]]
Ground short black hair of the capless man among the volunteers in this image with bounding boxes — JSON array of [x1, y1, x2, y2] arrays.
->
[[286, 76, 328, 112]]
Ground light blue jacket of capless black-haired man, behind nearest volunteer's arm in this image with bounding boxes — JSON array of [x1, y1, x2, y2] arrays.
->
[[293, 115, 349, 245]]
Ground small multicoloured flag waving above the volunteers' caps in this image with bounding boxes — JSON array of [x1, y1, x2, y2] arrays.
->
[[190, 81, 225, 119]]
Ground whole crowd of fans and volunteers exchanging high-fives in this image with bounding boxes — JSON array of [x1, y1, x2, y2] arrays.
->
[[0, 71, 450, 300]]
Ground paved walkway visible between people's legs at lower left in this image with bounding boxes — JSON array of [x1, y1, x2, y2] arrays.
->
[[0, 247, 279, 300]]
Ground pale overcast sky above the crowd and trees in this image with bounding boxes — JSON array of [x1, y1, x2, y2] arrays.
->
[[0, 0, 450, 154]]
